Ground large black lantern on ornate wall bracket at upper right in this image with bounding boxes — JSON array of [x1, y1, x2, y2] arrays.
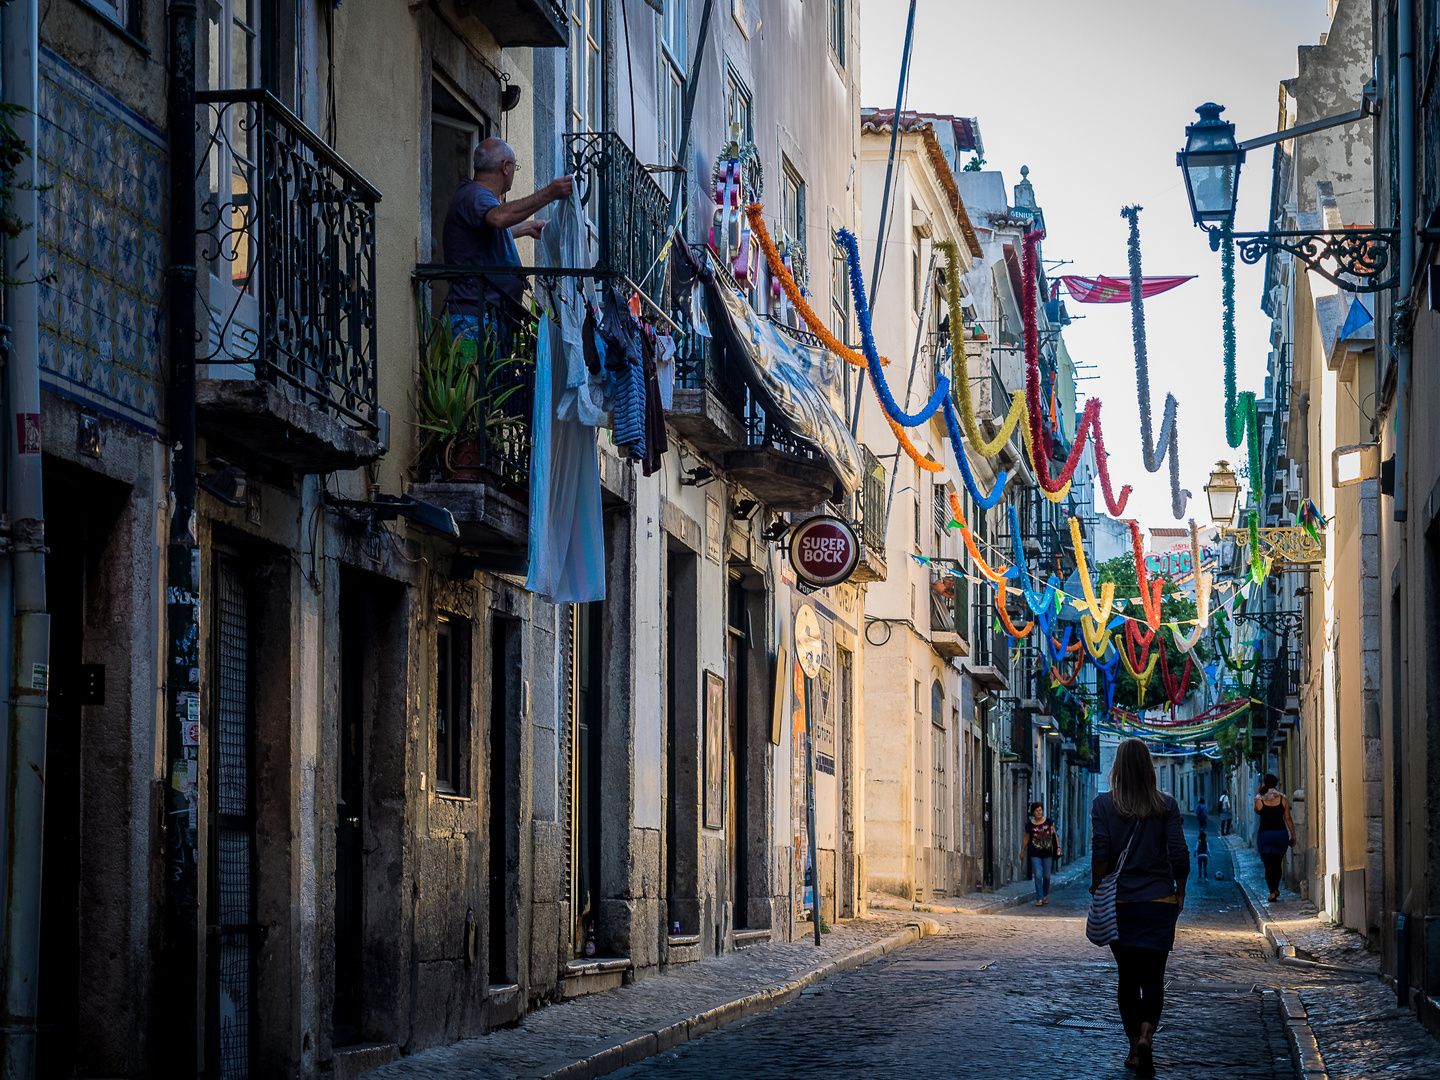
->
[[1175, 100, 1400, 292]]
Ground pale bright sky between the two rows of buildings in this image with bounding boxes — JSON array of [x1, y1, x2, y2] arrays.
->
[[860, 0, 1329, 527]]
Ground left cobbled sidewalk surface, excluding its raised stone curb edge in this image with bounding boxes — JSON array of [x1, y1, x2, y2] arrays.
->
[[364, 912, 922, 1080]]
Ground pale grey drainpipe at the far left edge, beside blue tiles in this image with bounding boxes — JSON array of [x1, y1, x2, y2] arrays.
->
[[0, 0, 50, 1080]]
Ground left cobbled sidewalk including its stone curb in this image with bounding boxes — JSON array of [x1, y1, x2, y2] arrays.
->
[[364, 912, 940, 1080]]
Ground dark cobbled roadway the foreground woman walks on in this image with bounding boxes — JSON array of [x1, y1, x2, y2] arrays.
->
[[615, 823, 1293, 1080]]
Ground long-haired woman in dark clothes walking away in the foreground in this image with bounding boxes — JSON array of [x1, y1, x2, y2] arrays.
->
[[1090, 739, 1189, 1077]]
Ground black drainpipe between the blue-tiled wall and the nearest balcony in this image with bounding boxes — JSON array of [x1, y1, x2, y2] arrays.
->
[[151, 0, 203, 1077]]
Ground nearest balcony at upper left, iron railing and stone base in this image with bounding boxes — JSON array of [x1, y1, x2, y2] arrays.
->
[[196, 89, 389, 474]]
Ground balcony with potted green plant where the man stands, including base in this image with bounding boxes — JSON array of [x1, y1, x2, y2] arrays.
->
[[410, 266, 538, 573]]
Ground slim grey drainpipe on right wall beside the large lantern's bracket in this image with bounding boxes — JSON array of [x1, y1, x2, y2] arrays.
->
[[1391, 3, 1416, 521]]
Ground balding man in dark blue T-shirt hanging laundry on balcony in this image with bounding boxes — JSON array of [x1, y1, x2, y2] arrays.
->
[[442, 138, 575, 308]]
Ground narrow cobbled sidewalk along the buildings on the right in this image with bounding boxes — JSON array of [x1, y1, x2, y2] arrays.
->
[[1231, 838, 1440, 1080]]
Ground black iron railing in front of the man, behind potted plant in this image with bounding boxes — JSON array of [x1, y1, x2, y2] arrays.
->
[[412, 265, 541, 492]]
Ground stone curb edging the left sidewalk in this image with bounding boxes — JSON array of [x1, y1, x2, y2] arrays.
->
[[524, 919, 940, 1080]]
